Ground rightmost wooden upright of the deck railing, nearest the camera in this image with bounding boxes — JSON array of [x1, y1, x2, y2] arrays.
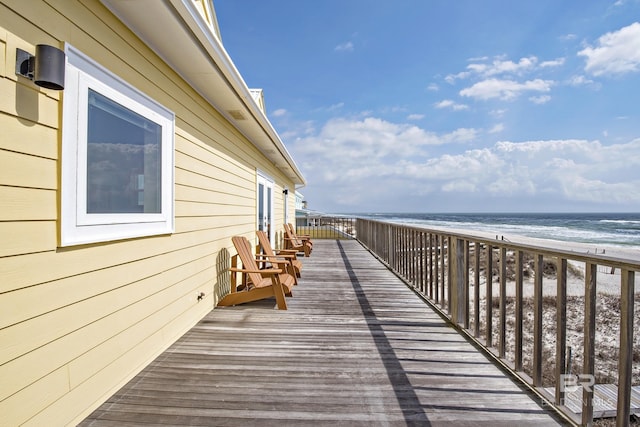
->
[[616, 269, 635, 427]]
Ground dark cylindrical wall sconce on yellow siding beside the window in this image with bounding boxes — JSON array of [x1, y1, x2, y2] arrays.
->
[[16, 44, 66, 90]]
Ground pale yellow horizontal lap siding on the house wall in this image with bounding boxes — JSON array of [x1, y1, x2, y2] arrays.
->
[[0, 0, 293, 425]]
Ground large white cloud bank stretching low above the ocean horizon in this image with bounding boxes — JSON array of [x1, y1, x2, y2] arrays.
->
[[290, 117, 640, 212]]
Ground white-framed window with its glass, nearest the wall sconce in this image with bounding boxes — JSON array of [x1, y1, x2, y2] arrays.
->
[[61, 45, 174, 246]]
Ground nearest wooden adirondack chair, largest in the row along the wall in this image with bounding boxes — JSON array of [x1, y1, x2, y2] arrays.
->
[[218, 236, 295, 310]]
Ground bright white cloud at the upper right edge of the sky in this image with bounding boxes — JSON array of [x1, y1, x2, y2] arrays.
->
[[578, 22, 640, 76]]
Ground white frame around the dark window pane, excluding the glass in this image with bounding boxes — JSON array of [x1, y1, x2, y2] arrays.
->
[[60, 44, 175, 246]]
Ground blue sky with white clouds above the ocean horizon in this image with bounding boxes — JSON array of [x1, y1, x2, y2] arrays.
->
[[214, 0, 640, 213]]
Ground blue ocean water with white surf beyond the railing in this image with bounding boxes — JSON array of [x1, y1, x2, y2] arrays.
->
[[358, 213, 640, 250]]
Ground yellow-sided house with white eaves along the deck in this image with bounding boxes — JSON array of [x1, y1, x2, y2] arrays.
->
[[0, 0, 304, 425]]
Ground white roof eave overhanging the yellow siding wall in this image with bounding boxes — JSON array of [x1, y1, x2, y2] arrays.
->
[[101, 0, 306, 185]]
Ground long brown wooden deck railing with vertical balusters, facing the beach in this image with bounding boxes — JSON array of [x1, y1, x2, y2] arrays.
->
[[348, 218, 640, 426]]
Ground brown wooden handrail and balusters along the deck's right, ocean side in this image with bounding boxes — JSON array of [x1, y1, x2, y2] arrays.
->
[[355, 218, 640, 426]]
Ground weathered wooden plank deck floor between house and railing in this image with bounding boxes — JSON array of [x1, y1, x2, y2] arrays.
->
[[81, 240, 558, 426]]
